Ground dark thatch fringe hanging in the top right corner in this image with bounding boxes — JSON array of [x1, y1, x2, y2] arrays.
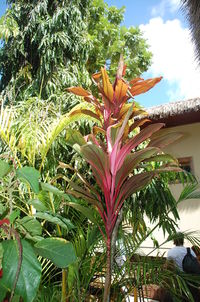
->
[[182, 0, 200, 62]]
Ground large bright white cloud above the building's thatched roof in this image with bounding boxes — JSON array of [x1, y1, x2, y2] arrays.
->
[[140, 17, 200, 100]]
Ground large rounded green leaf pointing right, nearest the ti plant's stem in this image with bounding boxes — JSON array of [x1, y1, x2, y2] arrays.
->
[[35, 238, 76, 268]]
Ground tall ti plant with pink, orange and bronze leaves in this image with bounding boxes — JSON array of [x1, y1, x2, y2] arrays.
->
[[67, 58, 181, 302]]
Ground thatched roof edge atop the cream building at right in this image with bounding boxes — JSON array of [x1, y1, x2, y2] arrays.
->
[[146, 98, 200, 127]]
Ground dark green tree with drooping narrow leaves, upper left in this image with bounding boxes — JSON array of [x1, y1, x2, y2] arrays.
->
[[0, 0, 90, 102]]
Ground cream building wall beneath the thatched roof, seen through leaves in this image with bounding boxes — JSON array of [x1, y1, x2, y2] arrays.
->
[[143, 123, 200, 254]]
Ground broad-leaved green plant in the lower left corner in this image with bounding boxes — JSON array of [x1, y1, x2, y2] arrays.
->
[[0, 160, 76, 302]]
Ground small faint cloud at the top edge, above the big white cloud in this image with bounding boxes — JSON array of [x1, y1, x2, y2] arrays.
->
[[151, 0, 181, 17]]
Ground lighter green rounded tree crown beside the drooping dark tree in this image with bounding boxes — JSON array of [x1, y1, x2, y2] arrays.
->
[[87, 0, 151, 80]]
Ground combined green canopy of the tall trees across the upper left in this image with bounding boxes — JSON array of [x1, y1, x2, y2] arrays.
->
[[0, 0, 151, 107]]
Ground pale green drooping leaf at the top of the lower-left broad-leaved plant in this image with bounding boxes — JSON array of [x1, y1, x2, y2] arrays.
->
[[16, 167, 40, 193]]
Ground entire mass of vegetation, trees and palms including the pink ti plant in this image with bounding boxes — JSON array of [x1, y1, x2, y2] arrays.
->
[[0, 0, 199, 302]]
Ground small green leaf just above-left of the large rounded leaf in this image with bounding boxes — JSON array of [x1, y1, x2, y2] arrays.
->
[[18, 216, 42, 236]]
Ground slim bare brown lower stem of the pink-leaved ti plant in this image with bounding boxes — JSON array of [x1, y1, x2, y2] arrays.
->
[[103, 238, 111, 302]]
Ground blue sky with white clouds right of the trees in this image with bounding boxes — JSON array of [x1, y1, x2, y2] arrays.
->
[[0, 0, 200, 107]]
